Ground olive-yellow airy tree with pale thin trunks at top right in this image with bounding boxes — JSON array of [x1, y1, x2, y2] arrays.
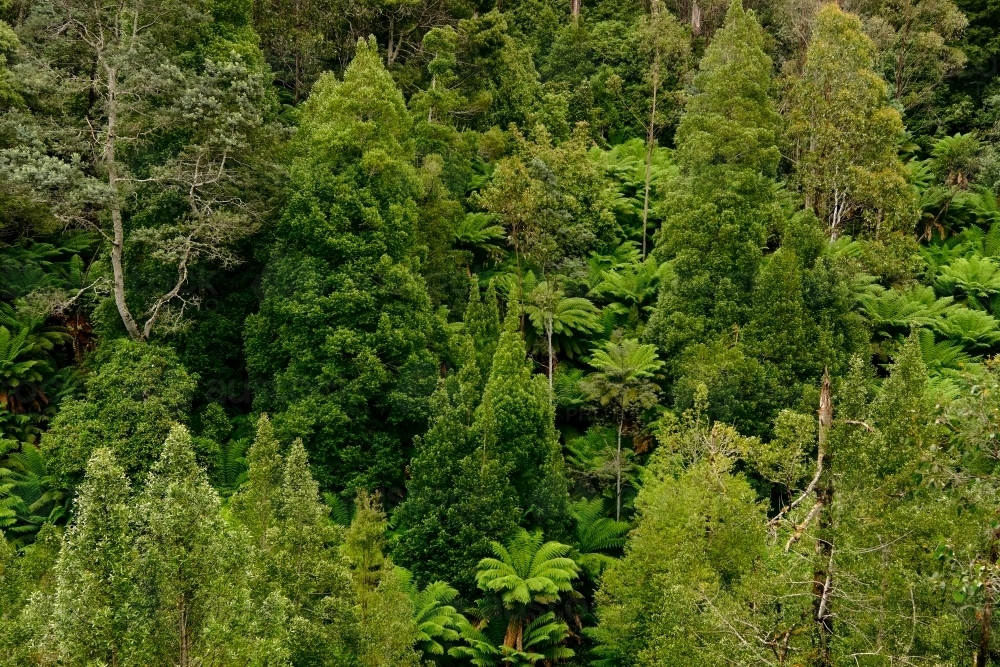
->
[[788, 4, 916, 239]]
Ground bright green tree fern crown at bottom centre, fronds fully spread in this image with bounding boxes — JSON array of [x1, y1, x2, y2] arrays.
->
[[476, 529, 579, 609]]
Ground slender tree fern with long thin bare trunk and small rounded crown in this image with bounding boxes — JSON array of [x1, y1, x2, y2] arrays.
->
[[584, 338, 663, 521]]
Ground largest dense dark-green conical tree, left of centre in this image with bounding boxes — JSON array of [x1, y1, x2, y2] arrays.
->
[[245, 39, 439, 496]]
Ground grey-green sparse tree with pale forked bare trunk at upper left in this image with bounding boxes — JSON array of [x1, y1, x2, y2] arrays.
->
[[5, 0, 278, 341]]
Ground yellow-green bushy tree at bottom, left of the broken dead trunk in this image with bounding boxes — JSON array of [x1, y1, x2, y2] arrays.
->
[[587, 402, 768, 667]]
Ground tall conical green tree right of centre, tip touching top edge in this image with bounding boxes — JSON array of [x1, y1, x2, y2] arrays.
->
[[647, 0, 780, 356]]
